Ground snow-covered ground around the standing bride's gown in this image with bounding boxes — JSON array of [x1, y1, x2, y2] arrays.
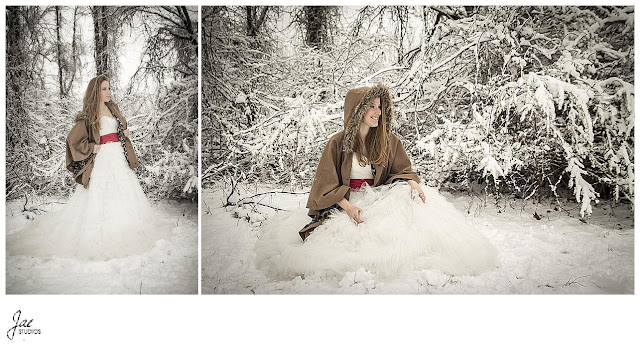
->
[[6, 198, 198, 294]]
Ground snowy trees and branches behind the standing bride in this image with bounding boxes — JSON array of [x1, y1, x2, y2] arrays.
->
[[6, 6, 199, 201]]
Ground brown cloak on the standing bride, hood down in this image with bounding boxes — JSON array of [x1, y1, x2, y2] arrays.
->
[[67, 101, 139, 188]]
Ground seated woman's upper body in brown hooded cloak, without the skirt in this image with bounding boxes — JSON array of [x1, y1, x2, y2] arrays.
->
[[300, 85, 425, 240]]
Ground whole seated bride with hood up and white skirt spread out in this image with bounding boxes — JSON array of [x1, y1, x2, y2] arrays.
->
[[256, 85, 499, 278]]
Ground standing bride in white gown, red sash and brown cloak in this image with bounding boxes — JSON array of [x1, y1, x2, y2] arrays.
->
[[7, 75, 172, 260]]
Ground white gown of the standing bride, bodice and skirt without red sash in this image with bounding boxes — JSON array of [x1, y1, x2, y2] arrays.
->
[[7, 116, 172, 260]]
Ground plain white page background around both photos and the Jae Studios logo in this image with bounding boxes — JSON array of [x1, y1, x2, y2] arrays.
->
[[0, 0, 640, 349]]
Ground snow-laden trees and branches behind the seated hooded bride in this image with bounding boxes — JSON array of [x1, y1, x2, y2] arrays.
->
[[202, 6, 635, 216]]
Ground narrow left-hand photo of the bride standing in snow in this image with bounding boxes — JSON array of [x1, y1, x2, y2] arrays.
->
[[5, 6, 199, 294]]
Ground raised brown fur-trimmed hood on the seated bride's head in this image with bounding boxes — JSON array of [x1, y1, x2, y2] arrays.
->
[[342, 84, 394, 152]]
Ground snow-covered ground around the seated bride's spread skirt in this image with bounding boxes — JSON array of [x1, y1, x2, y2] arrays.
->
[[202, 185, 634, 294]]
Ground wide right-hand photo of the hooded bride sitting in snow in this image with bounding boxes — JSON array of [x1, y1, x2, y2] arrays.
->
[[200, 6, 635, 294]]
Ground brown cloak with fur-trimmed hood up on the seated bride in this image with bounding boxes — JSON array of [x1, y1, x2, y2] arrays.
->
[[299, 85, 420, 240]]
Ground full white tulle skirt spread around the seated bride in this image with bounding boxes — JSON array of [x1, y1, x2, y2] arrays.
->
[[255, 182, 499, 278]]
